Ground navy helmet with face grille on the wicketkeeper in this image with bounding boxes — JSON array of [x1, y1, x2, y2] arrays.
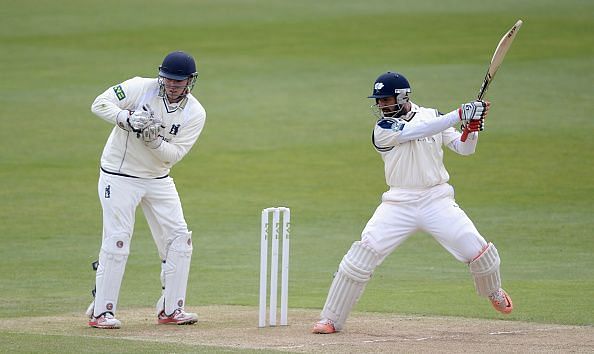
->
[[159, 51, 198, 96]]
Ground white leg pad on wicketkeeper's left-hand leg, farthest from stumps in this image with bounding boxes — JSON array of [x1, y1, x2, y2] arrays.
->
[[93, 235, 130, 317]]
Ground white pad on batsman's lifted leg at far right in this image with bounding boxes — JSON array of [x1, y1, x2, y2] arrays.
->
[[470, 243, 501, 296]]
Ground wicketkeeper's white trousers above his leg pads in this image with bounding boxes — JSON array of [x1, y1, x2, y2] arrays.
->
[[98, 171, 188, 260]]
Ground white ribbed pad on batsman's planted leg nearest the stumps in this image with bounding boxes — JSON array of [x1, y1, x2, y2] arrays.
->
[[321, 241, 380, 330]]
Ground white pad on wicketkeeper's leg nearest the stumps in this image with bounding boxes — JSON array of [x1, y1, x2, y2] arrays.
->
[[157, 232, 193, 315]]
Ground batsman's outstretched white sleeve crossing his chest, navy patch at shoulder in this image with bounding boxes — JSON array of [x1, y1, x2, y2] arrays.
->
[[373, 110, 460, 147]]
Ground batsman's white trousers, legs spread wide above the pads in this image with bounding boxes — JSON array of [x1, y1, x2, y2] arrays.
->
[[361, 183, 487, 263]]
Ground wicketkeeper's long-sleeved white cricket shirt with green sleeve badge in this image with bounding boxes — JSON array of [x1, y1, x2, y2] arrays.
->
[[91, 77, 206, 178]]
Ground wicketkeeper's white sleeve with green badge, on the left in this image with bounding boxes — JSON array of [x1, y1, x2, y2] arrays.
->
[[91, 78, 142, 124]]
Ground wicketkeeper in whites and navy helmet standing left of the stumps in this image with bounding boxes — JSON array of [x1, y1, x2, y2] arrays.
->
[[87, 51, 206, 328]]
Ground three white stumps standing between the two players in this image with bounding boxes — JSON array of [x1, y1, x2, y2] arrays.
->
[[258, 207, 291, 327]]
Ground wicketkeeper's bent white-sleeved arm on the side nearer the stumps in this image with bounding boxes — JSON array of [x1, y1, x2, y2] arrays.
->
[[143, 109, 206, 166]]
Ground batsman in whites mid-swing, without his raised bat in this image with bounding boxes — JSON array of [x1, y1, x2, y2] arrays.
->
[[312, 72, 513, 334]]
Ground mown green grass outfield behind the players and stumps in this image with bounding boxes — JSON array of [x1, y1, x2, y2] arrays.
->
[[0, 0, 594, 352]]
